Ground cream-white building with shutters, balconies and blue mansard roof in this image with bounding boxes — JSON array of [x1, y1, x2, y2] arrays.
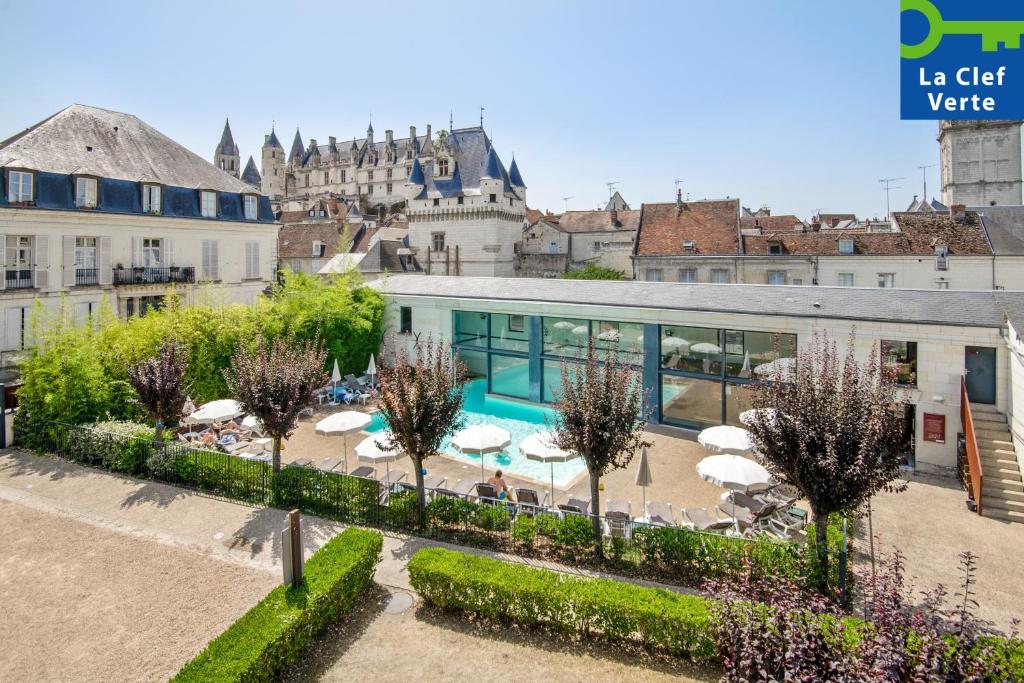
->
[[0, 104, 279, 364]]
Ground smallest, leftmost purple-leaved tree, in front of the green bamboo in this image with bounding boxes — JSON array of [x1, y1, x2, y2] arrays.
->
[[127, 341, 187, 441]]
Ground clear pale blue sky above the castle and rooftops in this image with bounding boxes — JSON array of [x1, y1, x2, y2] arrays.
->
[[0, 0, 939, 218]]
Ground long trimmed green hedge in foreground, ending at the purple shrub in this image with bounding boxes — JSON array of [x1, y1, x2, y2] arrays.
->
[[409, 548, 715, 661]]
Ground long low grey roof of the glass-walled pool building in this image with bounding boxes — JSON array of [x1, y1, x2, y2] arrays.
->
[[369, 274, 1024, 328]]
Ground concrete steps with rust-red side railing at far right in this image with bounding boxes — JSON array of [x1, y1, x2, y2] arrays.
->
[[971, 403, 1024, 523]]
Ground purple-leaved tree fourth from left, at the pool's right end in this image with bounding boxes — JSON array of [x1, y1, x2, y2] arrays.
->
[[552, 338, 650, 558]]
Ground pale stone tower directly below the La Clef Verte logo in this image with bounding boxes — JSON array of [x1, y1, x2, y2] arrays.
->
[[937, 120, 1022, 207]]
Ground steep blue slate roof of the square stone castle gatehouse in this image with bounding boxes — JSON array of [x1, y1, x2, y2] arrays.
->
[[409, 127, 522, 200]]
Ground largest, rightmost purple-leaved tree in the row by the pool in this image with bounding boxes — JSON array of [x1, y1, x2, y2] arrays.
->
[[750, 332, 906, 575]]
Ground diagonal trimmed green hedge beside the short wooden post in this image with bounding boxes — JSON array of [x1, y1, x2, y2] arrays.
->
[[172, 528, 383, 681]]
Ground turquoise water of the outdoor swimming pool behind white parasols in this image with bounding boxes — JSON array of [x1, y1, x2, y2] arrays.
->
[[366, 379, 586, 486]]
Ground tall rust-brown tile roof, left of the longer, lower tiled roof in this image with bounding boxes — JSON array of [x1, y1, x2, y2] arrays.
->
[[637, 200, 739, 256]]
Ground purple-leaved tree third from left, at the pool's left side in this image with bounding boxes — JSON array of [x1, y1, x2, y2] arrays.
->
[[380, 339, 466, 527]]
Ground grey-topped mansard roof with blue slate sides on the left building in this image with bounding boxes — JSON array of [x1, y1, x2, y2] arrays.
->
[[0, 104, 273, 223]]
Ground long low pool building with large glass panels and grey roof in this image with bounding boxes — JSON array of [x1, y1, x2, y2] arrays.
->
[[372, 275, 1024, 479]]
